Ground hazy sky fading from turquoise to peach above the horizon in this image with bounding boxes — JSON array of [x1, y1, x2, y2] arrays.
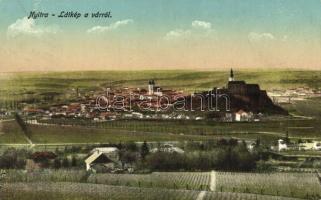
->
[[0, 0, 321, 71]]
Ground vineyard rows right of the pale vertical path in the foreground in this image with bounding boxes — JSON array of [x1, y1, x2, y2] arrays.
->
[[216, 172, 321, 198]]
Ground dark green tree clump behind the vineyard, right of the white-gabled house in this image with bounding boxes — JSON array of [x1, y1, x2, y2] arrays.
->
[[146, 143, 256, 171]]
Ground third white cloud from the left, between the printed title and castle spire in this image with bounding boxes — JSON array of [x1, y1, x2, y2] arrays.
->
[[164, 20, 214, 40]]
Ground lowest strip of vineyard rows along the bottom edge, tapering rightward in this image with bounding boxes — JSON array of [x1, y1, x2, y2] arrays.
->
[[1, 182, 300, 200]]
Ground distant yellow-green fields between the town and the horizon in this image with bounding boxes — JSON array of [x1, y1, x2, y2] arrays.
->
[[0, 70, 321, 104]]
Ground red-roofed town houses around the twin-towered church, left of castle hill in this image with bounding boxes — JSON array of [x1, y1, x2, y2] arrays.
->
[[22, 80, 184, 121]]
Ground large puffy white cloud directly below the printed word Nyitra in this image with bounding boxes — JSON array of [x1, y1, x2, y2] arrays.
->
[[7, 17, 58, 37]]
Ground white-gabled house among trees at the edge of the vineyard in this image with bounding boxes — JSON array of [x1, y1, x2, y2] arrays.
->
[[85, 147, 121, 171]]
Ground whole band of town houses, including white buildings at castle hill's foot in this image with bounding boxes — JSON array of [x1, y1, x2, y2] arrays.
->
[[22, 80, 262, 122]]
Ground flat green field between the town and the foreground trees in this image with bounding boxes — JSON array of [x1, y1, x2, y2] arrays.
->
[[0, 116, 321, 144]]
